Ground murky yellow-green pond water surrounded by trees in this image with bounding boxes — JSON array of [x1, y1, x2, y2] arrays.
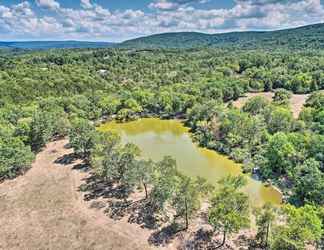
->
[[99, 118, 282, 206]]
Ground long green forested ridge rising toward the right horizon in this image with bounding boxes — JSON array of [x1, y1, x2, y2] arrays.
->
[[118, 24, 324, 49]]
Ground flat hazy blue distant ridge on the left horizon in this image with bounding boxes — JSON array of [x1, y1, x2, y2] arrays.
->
[[0, 41, 115, 50]]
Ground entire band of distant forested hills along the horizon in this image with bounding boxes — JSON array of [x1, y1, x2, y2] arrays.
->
[[0, 23, 324, 51]]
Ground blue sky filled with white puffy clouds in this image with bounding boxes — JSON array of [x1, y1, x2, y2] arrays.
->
[[0, 0, 324, 42]]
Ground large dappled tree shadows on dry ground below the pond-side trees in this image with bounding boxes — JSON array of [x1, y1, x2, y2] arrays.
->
[[74, 170, 187, 246]]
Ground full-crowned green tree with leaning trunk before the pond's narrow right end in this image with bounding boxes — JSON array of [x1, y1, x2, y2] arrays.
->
[[208, 176, 250, 248]]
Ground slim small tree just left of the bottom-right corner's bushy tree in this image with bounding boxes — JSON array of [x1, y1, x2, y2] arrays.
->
[[255, 203, 276, 249]]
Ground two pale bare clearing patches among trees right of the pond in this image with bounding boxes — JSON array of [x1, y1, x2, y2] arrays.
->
[[233, 92, 309, 119]]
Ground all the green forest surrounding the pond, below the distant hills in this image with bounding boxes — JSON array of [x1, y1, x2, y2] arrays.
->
[[0, 43, 324, 250]]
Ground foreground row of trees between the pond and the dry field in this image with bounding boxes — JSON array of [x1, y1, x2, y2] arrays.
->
[[69, 119, 324, 250]]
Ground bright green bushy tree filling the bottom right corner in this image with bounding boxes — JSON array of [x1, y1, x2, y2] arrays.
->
[[271, 205, 323, 250]]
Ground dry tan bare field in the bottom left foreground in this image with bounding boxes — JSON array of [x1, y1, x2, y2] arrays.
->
[[0, 140, 157, 250]]
